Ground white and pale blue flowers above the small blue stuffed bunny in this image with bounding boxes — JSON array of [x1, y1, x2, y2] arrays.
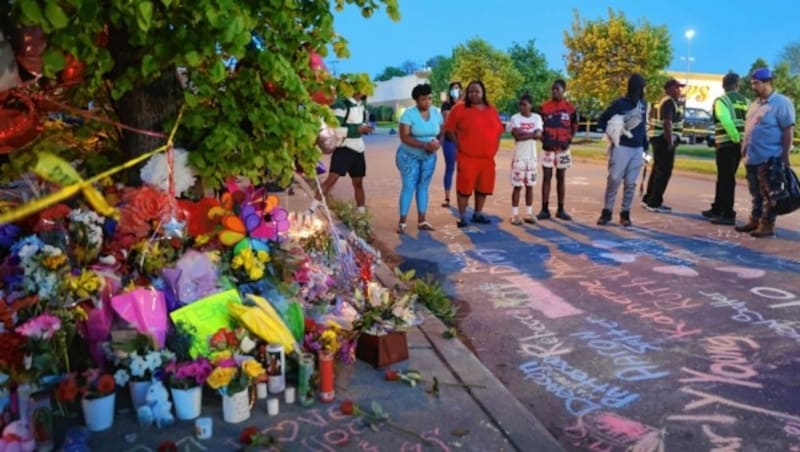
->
[[111, 334, 175, 386]]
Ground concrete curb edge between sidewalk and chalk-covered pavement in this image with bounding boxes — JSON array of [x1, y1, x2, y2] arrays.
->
[[375, 262, 564, 452]]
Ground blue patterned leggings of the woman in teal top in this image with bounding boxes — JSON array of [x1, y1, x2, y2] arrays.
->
[[395, 147, 436, 217]]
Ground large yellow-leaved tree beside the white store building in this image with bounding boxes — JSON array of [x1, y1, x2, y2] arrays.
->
[[564, 9, 672, 106]]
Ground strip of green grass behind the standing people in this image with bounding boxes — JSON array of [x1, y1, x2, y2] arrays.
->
[[500, 137, 800, 177]]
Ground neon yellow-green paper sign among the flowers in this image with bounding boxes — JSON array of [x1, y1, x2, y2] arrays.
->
[[169, 289, 242, 358]]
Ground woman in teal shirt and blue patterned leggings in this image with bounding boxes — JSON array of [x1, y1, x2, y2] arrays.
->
[[395, 84, 444, 234]]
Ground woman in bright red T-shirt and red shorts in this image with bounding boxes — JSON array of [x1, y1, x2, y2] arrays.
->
[[445, 80, 503, 228]]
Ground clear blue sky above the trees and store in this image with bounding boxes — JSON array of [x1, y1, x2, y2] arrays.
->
[[326, 0, 800, 77]]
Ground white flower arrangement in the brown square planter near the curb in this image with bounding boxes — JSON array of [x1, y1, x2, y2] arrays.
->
[[352, 282, 419, 336]]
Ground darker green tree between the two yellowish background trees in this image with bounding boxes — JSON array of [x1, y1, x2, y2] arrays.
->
[[501, 39, 563, 113]]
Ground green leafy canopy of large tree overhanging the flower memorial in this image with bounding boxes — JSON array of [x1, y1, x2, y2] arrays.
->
[[0, 0, 399, 186]]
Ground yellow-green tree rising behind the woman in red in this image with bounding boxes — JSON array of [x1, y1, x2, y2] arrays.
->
[[451, 38, 523, 105]]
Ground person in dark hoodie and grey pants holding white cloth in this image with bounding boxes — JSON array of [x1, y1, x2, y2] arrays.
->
[[597, 74, 648, 226]]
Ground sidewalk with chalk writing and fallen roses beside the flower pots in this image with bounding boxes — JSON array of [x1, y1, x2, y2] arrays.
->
[[72, 317, 562, 452]]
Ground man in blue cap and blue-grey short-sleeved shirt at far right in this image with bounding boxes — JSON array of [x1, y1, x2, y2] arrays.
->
[[736, 68, 795, 238]]
